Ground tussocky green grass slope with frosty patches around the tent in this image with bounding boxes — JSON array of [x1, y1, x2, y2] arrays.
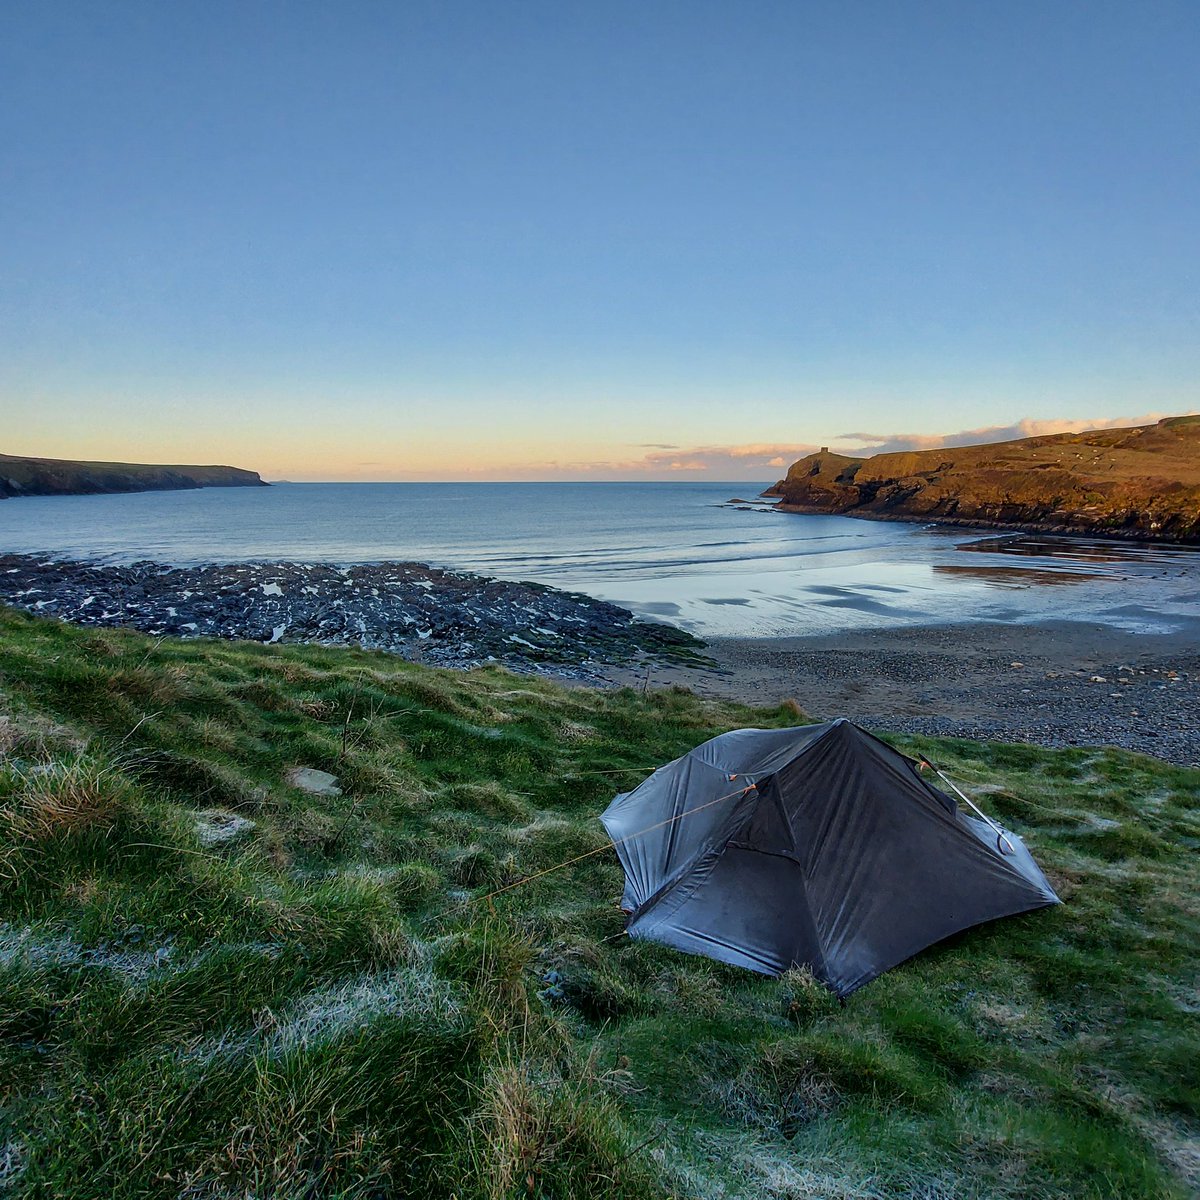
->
[[0, 610, 1200, 1200]]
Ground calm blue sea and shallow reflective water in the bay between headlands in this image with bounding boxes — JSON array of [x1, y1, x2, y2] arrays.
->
[[0, 480, 1200, 637]]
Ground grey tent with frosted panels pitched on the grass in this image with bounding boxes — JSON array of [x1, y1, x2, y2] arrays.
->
[[601, 720, 1060, 996]]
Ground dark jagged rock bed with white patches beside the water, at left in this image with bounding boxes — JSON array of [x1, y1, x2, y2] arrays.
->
[[0, 554, 703, 679]]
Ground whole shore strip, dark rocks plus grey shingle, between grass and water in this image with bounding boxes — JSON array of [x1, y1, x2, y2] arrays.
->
[[7, 554, 1200, 766]]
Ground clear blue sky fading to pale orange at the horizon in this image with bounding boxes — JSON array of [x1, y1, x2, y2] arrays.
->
[[0, 0, 1200, 479]]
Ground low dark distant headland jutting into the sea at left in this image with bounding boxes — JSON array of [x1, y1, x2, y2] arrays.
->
[[0, 454, 268, 499]]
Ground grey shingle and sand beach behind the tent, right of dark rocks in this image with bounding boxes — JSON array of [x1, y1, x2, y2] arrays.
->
[[607, 618, 1200, 766]]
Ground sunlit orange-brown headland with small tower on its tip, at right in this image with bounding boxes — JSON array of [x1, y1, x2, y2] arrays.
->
[[764, 416, 1200, 544]]
